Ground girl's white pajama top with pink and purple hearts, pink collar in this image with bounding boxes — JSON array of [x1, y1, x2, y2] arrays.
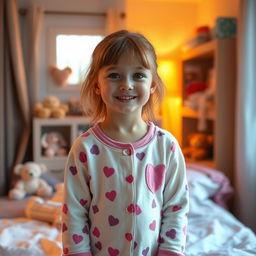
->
[[62, 123, 188, 256]]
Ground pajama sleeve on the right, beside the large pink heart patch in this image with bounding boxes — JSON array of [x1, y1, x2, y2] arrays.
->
[[157, 142, 188, 256]]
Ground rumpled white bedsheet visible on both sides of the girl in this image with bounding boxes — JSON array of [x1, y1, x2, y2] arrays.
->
[[0, 198, 256, 256]]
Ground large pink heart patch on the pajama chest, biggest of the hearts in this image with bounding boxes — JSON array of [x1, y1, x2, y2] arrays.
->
[[146, 164, 166, 193]]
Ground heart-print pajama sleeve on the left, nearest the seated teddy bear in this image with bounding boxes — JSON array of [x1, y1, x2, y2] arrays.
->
[[62, 138, 92, 256]]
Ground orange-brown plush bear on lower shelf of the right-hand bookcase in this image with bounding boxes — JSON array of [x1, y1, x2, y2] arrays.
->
[[182, 132, 213, 161]]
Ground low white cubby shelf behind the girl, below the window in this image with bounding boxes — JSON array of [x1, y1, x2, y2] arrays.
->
[[33, 116, 90, 180]]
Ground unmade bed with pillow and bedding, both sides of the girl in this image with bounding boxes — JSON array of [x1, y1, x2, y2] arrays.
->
[[0, 164, 256, 256]]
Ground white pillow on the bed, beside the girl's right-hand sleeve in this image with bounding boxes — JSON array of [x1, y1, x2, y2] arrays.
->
[[187, 168, 220, 200]]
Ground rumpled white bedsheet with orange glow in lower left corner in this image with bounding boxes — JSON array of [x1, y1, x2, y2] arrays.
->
[[0, 218, 61, 256]]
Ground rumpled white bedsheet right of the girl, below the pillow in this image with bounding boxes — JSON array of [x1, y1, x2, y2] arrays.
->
[[186, 195, 256, 256]]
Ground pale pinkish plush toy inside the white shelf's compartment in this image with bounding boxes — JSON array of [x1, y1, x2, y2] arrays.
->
[[41, 132, 67, 157]]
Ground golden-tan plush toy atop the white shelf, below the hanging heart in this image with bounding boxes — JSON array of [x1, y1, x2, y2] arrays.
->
[[34, 96, 69, 118]]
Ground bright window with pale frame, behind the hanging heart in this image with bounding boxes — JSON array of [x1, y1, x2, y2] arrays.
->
[[46, 28, 104, 91]]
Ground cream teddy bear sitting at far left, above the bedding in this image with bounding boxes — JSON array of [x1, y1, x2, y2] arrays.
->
[[8, 162, 53, 200]]
